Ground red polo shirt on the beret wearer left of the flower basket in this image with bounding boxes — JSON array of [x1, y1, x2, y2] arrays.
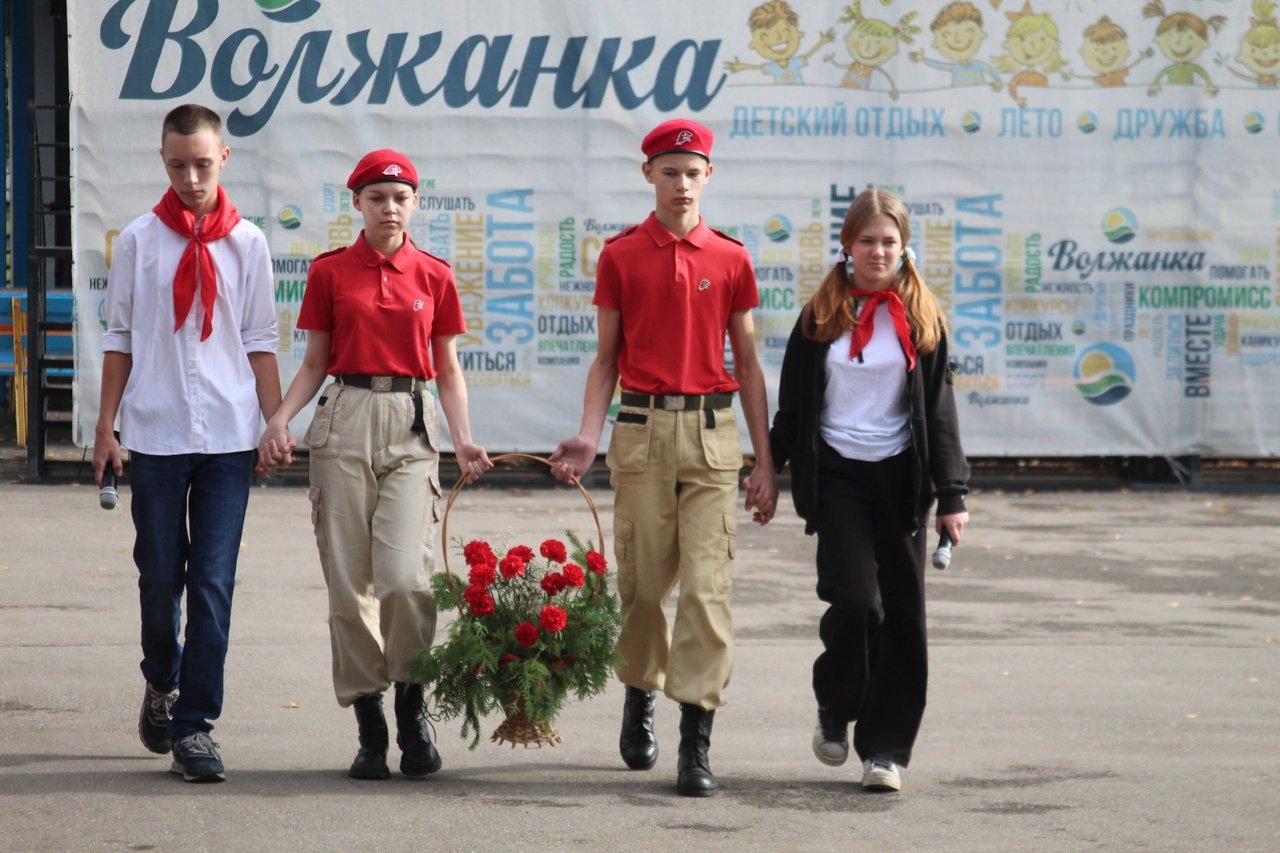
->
[[297, 232, 466, 379]]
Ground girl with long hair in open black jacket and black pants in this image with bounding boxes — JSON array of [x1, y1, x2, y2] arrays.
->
[[769, 190, 969, 790]]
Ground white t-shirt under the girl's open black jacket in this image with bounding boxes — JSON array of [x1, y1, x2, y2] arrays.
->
[[818, 302, 911, 462]]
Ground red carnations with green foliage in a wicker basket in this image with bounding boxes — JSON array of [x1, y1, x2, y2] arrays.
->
[[416, 532, 622, 749]]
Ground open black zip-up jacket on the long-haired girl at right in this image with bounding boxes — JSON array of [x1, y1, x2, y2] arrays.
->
[[769, 314, 969, 534]]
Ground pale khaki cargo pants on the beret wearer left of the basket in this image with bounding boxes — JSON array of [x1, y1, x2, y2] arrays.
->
[[303, 384, 440, 707]]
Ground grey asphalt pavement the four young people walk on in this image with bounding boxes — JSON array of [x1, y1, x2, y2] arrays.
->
[[0, 478, 1280, 852]]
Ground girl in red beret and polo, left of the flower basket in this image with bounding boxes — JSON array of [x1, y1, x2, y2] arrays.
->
[[259, 149, 493, 779]]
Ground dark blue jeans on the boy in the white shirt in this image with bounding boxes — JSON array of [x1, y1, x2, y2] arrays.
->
[[129, 451, 253, 739]]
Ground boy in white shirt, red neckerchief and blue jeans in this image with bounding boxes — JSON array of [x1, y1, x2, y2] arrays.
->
[[93, 104, 280, 783]]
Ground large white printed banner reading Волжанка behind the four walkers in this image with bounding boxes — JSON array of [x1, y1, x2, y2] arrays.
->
[[69, 0, 1280, 457]]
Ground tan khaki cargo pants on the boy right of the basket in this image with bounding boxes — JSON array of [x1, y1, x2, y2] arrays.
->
[[605, 406, 742, 710]]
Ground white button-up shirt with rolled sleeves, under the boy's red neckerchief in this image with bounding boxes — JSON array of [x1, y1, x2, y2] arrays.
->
[[102, 213, 278, 456]]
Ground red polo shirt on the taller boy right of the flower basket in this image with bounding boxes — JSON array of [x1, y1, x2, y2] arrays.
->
[[594, 213, 760, 394]]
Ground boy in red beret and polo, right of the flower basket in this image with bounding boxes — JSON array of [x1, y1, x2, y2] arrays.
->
[[552, 119, 777, 797]]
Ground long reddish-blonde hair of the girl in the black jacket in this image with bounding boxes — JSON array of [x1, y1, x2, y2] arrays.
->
[[800, 188, 947, 353]]
